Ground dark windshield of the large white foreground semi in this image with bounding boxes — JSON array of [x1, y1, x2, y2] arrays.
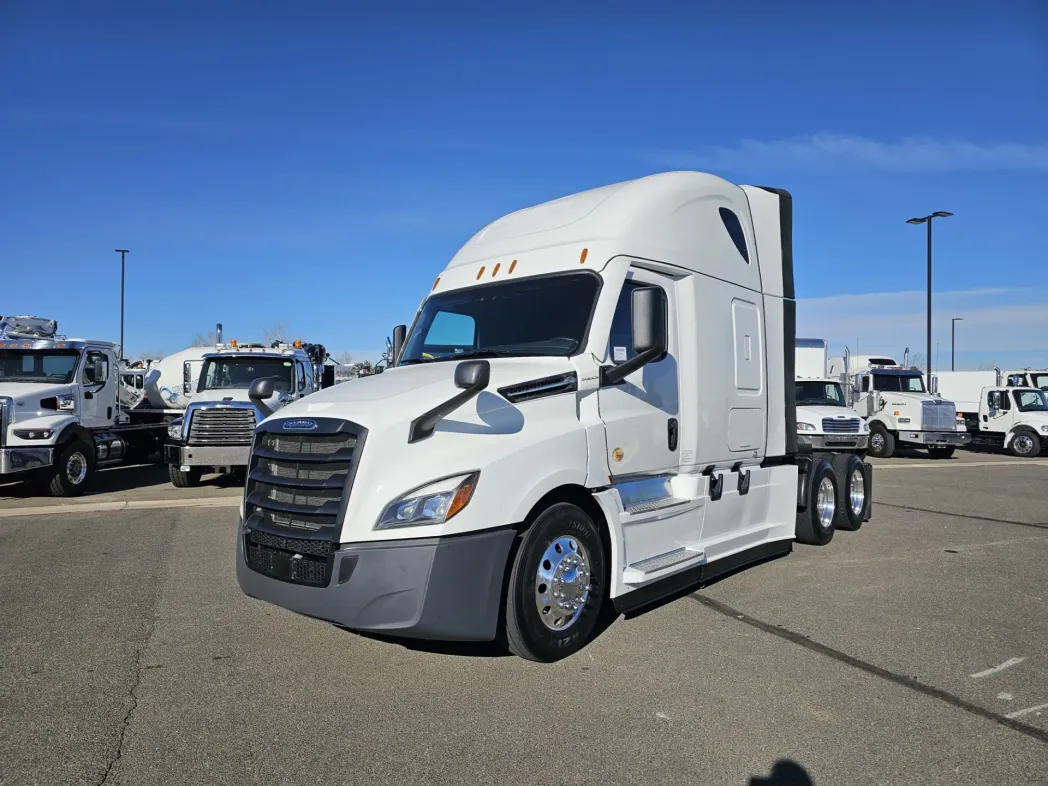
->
[[400, 272, 601, 365]]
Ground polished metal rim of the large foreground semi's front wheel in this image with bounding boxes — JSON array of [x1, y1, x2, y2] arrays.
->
[[534, 536, 590, 631]]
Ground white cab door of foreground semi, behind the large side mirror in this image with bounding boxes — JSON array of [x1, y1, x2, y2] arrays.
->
[[597, 268, 680, 480]]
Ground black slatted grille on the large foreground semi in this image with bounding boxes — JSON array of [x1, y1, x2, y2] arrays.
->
[[244, 418, 367, 586]]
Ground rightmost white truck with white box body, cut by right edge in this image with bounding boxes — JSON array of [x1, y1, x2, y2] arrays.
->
[[936, 369, 1048, 458]]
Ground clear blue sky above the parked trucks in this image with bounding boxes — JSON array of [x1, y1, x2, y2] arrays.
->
[[0, 0, 1048, 367]]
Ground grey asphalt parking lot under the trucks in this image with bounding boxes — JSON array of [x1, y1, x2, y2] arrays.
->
[[0, 453, 1048, 786]]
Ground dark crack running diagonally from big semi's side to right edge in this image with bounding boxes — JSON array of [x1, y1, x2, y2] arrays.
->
[[687, 593, 1048, 743]]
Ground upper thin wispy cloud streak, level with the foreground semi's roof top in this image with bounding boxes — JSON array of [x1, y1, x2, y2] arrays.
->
[[649, 132, 1048, 172]]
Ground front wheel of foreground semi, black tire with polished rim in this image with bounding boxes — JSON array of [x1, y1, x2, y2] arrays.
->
[[504, 502, 607, 663]]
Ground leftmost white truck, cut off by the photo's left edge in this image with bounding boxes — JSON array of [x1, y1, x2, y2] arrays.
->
[[0, 316, 173, 497]]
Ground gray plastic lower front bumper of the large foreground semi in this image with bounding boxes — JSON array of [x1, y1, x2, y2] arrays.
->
[[237, 524, 517, 641]]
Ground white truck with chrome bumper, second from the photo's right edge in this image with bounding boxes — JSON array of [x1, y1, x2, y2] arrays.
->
[[829, 350, 971, 459]]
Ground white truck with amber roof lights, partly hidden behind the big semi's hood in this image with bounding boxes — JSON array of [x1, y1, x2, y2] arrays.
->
[[163, 337, 334, 488]]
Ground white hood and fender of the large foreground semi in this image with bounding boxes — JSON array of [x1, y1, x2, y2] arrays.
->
[[256, 357, 591, 542]]
